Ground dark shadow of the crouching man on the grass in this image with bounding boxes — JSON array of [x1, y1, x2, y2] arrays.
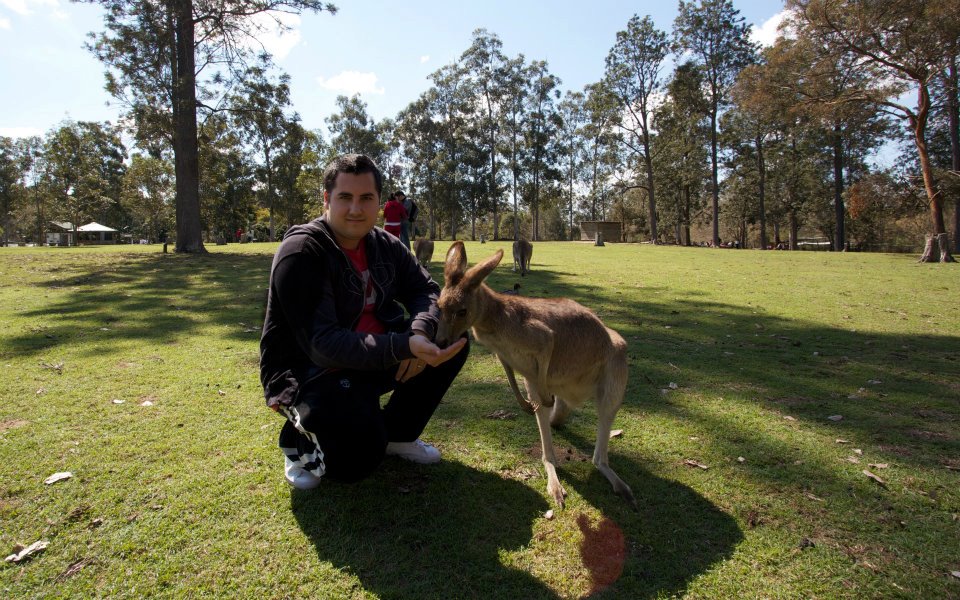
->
[[290, 459, 557, 598]]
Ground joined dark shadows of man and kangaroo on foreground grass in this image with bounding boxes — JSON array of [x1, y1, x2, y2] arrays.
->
[[290, 459, 742, 599]]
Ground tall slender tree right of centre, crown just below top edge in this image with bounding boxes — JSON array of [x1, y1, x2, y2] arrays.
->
[[605, 15, 669, 242]]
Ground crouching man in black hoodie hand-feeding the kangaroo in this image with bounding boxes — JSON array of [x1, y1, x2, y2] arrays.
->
[[260, 154, 468, 490]]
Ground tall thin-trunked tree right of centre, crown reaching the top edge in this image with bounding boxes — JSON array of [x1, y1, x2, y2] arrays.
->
[[674, 0, 756, 245]]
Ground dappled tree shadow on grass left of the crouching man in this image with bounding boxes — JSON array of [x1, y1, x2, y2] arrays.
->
[[0, 254, 272, 357]]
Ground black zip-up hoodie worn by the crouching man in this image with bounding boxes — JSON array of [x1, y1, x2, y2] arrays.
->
[[260, 216, 440, 408]]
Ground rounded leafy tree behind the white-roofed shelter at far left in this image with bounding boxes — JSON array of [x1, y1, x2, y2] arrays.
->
[[41, 121, 126, 243]]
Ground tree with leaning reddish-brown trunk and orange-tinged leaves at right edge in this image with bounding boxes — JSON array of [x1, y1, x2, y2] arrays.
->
[[787, 0, 960, 262]]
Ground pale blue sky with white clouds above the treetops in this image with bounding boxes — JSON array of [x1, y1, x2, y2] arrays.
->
[[0, 0, 782, 137]]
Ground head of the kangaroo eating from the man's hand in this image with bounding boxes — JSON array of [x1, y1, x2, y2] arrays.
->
[[437, 242, 503, 347]]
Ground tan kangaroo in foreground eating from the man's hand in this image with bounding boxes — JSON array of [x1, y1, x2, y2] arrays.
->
[[437, 242, 636, 508]]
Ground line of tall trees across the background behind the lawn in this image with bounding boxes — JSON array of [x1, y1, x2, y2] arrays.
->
[[0, 0, 960, 260]]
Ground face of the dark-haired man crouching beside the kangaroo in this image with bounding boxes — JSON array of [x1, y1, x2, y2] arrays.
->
[[323, 173, 380, 250]]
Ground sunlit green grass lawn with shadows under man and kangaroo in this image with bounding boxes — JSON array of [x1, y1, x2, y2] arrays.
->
[[0, 242, 960, 599]]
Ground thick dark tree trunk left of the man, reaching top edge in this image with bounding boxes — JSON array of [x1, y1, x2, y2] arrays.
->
[[173, 0, 206, 252]]
